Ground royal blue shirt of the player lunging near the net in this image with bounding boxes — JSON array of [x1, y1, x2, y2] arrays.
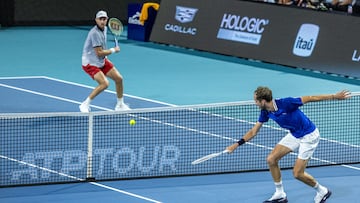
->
[[258, 97, 316, 138]]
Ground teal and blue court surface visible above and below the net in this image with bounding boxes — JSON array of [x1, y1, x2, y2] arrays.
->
[[0, 27, 360, 203]]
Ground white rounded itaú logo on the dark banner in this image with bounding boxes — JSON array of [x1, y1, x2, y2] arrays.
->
[[293, 24, 320, 57]]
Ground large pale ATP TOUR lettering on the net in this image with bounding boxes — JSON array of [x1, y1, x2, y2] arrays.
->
[[11, 145, 180, 181]]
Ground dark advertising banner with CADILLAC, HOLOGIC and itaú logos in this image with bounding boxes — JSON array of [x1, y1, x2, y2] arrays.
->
[[150, 0, 360, 78]]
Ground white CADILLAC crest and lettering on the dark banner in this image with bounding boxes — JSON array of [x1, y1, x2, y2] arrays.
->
[[165, 6, 199, 35]]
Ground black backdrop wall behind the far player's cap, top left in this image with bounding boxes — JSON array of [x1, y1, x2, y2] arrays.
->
[[0, 0, 160, 26]]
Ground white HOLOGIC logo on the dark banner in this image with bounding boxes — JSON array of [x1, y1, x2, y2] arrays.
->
[[217, 13, 270, 45]]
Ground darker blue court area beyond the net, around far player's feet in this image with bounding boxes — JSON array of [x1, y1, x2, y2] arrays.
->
[[0, 77, 170, 113]]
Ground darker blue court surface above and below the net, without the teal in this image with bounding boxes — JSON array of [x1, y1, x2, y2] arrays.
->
[[0, 77, 360, 203]]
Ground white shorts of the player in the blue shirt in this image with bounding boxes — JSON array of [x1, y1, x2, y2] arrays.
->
[[279, 128, 320, 160]]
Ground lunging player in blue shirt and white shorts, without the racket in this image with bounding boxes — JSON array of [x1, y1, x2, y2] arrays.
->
[[227, 86, 351, 203]]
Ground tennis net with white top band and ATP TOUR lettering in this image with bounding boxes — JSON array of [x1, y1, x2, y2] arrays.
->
[[0, 93, 360, 187]]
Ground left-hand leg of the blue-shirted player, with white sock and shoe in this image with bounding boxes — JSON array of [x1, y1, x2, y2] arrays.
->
[[264, 144, 292, 203]]
